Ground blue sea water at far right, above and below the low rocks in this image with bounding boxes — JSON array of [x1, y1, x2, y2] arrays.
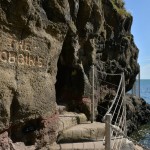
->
[[132, 79, 150, 149]]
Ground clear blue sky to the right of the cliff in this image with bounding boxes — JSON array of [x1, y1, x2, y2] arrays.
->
[[124, 0, 150, 79]]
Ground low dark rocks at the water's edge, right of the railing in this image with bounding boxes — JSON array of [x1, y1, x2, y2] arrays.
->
[[126, 94, 150, 134]]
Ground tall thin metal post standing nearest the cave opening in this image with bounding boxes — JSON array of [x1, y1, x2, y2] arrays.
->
[[91, 65, 94, 123]]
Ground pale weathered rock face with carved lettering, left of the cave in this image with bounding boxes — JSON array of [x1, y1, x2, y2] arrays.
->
[[0, 0, 68, 146]]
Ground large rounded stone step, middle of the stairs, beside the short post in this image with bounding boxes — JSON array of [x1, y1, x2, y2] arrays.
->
[[57, 122, 105, 143]]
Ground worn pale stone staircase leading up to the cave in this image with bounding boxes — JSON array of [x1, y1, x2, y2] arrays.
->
[[50, 105, 105, 150]]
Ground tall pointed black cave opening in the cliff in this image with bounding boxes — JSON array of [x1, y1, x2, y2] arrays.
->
[[55, 29, 84, 105]]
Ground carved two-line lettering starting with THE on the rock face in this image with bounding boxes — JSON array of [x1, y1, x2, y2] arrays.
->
[[0, 38, 44, 68]]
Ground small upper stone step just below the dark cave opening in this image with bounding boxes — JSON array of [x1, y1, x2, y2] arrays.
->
[[58, 112, 87, 132]]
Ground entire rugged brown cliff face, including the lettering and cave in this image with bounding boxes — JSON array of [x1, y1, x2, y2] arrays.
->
[[0, 0, 139, 146]]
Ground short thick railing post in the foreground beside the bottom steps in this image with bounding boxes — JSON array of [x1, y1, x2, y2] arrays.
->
[[105, 114, 112, 150]]
